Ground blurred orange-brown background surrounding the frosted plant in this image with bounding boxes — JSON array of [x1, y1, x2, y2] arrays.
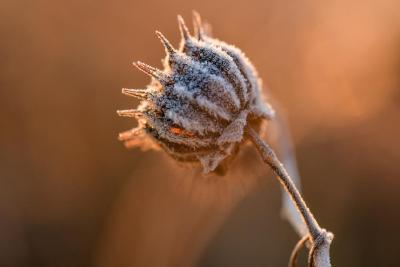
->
[[0, 0, 400, 267]]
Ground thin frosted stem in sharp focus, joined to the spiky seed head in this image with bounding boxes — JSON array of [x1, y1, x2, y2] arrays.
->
[[246, 126, 333, 267]]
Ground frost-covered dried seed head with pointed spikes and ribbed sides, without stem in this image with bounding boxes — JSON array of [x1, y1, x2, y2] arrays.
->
[[118, 13, 273, 174]]
